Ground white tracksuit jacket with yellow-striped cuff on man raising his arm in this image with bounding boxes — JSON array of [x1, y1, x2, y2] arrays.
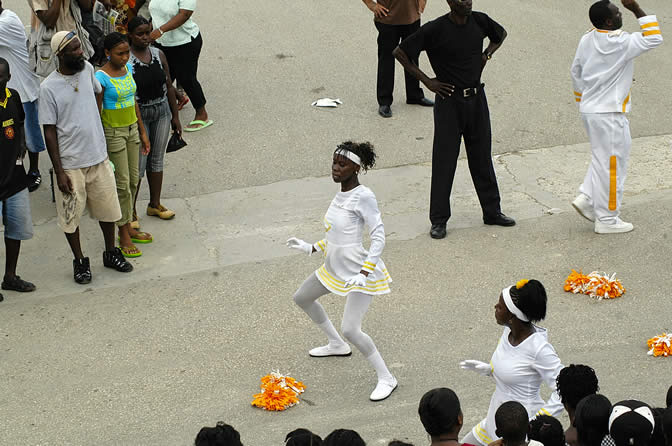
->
[[571, 15, 663, 113]]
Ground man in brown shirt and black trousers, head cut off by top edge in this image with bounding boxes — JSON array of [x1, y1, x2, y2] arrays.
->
[[362, 0, 434, 118]]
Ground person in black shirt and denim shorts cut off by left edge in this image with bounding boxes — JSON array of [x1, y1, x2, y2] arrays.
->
[[0, 57, 35, 301]]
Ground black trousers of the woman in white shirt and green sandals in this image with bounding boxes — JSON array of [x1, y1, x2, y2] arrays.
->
[[156, 33, 206, 110]]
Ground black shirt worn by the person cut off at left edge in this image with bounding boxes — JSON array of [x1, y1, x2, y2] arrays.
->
[[0, 88, 30, 200]]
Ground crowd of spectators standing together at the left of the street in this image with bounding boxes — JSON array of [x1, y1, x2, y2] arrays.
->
[[0, 0, 213, 301]]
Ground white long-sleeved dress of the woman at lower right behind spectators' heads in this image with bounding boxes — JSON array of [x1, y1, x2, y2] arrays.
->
[[473, 325, 563, 444]]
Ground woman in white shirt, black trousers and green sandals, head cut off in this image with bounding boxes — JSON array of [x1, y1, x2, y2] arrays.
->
[[149, 0, 213, 132]]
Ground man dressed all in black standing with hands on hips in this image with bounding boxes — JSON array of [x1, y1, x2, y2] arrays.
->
[[393, 0, 516, 239]]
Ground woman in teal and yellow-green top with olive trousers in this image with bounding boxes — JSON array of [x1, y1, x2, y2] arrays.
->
[[96, 32, 152, 257]]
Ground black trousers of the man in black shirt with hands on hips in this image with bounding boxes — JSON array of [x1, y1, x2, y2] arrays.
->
[[429, 86, 501, 224]]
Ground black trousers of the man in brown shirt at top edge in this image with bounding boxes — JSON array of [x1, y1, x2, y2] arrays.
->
[[374, 20, 425, 105]]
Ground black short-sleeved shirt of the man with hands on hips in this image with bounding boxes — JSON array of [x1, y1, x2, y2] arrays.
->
[[399, 11, 504, 88]]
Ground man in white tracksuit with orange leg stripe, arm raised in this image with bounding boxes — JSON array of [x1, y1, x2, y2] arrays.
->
[[571, 0, 663, 234]]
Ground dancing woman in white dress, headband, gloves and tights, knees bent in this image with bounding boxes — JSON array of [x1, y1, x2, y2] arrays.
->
[[286, 141, 397, 401]]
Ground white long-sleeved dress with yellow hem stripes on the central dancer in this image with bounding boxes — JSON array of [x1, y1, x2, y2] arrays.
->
[[314, 185, 392, 296]]
